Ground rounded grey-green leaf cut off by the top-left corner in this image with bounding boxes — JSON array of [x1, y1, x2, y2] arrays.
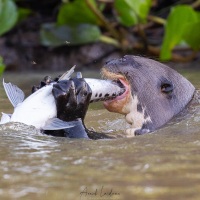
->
[[0, 0, 18, 35]]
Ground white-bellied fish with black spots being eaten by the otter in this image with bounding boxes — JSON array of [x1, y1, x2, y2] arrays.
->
[[0, 66, 125, 130]]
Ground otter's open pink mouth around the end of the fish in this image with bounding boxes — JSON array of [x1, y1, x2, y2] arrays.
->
[[101, 68, 130, 105]]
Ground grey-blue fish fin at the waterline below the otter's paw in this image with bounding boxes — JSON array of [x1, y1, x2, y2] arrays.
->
[[42, 118, 79, 130]]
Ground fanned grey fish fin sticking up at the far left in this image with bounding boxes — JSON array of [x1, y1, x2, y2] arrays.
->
[[3, 79, 25, 108]]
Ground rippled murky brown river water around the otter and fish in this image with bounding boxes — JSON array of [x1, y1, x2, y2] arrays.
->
[[0, 71, 200, 200]]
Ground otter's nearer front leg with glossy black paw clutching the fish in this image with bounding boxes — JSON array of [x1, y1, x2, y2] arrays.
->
[[52, 78, 92, 138]]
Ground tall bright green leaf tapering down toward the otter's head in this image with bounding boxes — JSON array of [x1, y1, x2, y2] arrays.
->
[[160, 5, 198, 60]]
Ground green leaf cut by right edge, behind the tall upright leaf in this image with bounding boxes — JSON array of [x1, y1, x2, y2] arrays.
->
[[183, 21, 200, 50]]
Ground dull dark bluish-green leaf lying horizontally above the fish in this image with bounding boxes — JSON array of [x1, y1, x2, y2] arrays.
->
[[40, 24, 101, 47]]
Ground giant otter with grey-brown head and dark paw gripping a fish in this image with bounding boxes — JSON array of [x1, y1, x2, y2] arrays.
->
[[36, 55, 195, 137]]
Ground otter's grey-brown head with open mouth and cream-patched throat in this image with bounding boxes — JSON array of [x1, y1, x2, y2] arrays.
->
[[102, 55, 195, 136]]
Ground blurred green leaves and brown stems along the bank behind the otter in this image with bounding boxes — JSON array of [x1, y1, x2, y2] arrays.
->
[[0, 0, 200, 72]]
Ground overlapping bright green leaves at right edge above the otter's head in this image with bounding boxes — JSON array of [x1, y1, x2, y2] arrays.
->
[[160, 5, 200, 60]]
